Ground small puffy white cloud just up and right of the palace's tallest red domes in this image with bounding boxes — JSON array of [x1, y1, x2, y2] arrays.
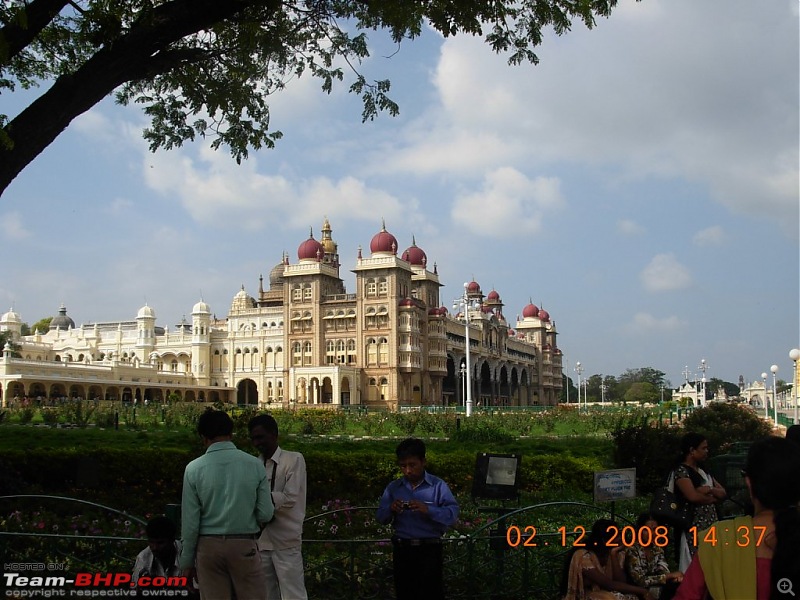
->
[[451, 167, 564, 237]]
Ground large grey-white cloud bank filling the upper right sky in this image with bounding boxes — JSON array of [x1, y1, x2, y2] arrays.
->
[[380, 0, 800, 227]]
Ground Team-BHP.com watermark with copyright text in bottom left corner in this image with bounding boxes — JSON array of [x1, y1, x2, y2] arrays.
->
[[0, 562, 191, 598]]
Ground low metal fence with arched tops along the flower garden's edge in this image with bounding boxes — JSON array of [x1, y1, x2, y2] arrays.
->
[[0, 496, 640, 600]]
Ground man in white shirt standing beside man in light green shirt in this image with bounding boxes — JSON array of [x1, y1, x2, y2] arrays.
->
[[248, 415, 308, 600]]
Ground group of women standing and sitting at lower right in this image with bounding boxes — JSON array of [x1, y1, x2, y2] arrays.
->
[[562, 426, 800, 600]]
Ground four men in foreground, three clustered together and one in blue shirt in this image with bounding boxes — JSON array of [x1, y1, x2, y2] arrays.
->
[[156, 410, 459, 600]]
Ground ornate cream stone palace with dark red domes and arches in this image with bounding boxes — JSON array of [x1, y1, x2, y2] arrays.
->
[[0, 219, 562, 409]]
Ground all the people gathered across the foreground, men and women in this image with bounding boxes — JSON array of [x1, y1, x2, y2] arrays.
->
[[138, 410, 800, 600]]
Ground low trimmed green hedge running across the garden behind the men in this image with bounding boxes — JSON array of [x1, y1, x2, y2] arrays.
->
[[0, 447, 603, 515]]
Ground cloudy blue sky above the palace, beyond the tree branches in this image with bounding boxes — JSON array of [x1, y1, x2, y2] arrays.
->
[[0, 0, 800, 386]]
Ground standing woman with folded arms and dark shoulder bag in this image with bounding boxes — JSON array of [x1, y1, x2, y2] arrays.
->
[[675, 432, 727, 572]]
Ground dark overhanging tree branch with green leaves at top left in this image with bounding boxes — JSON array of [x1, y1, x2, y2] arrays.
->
[[0, 0, 617, 194]]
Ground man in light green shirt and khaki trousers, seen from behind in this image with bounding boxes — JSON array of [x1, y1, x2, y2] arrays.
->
[[180, 410, 273, 600]]
